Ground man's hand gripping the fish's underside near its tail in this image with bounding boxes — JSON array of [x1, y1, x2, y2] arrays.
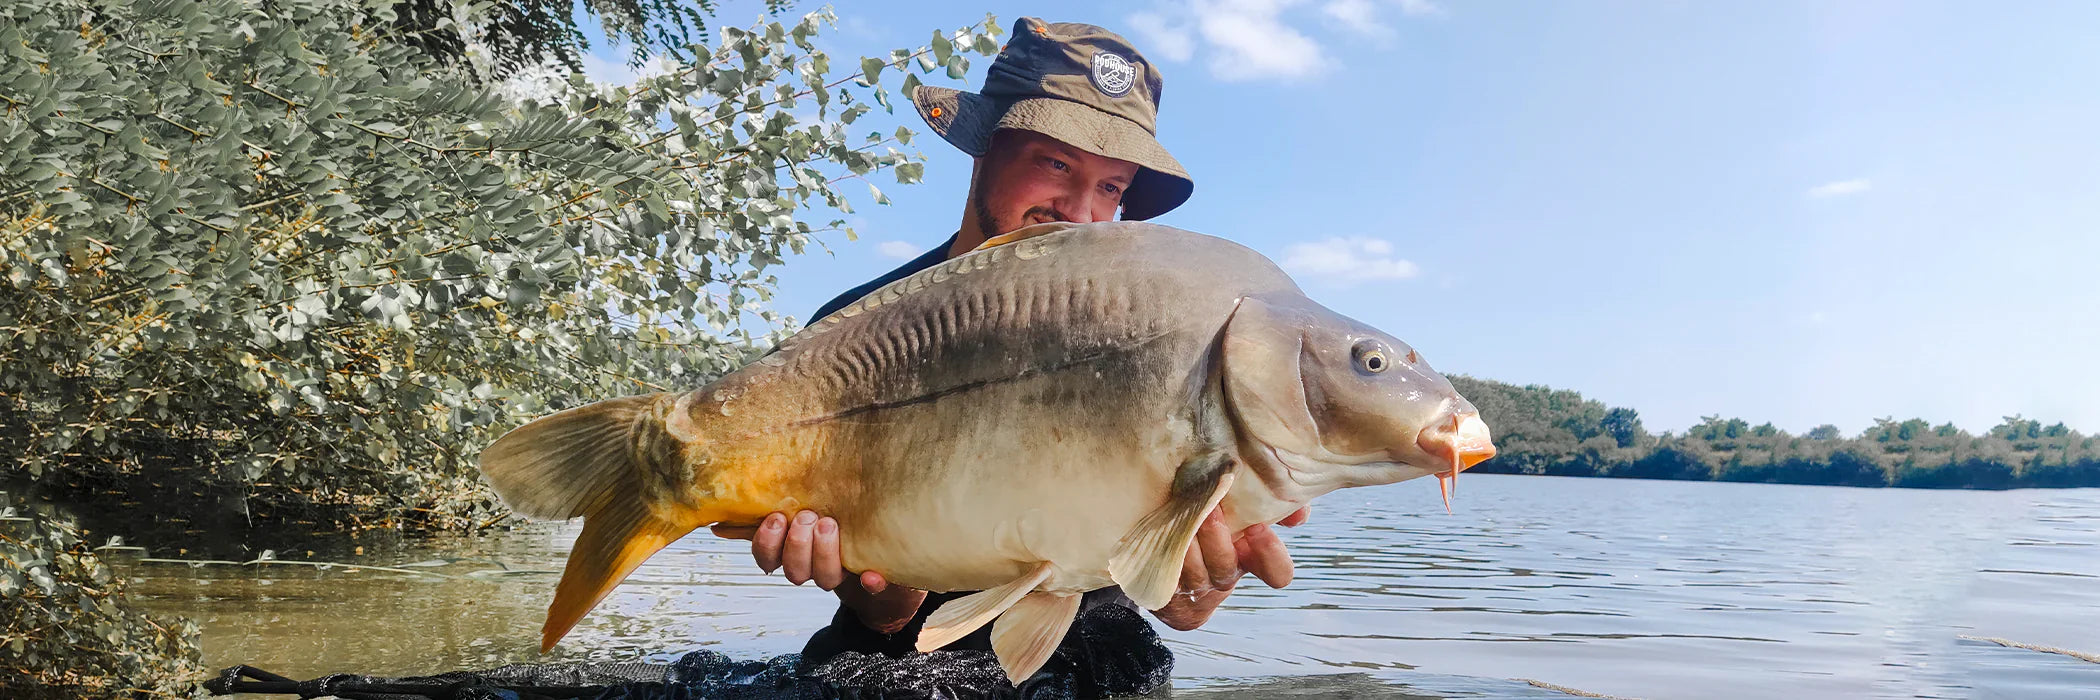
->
[[710, 511, 926, 635]]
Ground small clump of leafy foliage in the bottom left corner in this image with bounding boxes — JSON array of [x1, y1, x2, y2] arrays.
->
[[0, 492, 204, 698]]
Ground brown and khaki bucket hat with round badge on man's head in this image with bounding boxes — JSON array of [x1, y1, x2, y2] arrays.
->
[[911, 17, 1195, 221]]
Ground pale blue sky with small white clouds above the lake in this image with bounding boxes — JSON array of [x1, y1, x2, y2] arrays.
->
[[567, 0, 2100, 433]]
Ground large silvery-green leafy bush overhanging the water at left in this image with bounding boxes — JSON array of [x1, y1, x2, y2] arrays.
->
[[0, 0, 998, 526]]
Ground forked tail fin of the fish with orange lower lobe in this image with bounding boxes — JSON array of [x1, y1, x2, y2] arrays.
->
[[481, 393, 699, 652]]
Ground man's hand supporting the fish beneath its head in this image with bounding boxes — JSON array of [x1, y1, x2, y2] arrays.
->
[[1153, 507, 1313, 631]]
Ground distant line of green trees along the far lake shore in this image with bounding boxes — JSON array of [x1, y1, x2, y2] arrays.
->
[[1451, 376, 2100, 488]]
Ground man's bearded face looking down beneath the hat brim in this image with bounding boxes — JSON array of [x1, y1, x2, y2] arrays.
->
[[972, 128, 1138, 238]]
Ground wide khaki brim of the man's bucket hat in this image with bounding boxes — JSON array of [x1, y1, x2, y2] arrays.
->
[[911, 84, 1195, 221]]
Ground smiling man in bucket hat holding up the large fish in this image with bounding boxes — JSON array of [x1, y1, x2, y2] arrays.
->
[[714, 17, 1306, 662]]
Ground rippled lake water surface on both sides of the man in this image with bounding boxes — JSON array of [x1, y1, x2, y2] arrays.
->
[[126, 475, 2100, 698]]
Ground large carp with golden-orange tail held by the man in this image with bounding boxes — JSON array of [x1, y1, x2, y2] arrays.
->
[[479, 221, 1495, 683]]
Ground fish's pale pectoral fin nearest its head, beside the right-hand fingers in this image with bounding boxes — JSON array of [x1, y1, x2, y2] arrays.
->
[[1109, 468, 1233, 610]]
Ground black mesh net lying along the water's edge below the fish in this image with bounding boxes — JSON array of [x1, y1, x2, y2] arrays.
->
[[206, 605, 1174, 700]]
